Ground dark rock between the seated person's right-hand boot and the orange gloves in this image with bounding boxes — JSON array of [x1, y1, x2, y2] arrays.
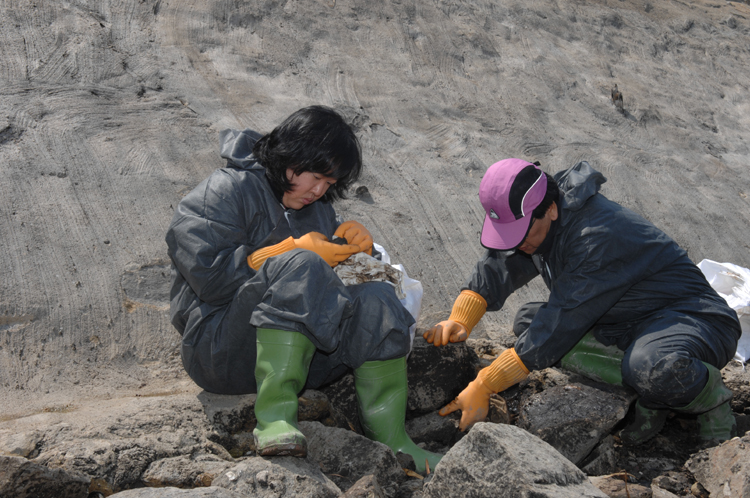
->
[[407, 335, 479, 418]]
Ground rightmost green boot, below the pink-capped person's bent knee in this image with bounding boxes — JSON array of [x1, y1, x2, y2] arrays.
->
[[675, 362, 737, 441]]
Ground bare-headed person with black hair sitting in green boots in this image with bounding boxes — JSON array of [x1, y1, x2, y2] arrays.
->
[[166, 106, 441, 472]]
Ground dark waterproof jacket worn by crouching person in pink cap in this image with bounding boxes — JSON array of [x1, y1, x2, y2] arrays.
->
[[463, 162, 739, 370]]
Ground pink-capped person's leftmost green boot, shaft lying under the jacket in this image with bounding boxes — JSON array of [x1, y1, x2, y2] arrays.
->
[[560, 332, 625, 386]]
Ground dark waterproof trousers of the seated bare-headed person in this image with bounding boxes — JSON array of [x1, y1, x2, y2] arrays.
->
[[181, 249, 414, 394]]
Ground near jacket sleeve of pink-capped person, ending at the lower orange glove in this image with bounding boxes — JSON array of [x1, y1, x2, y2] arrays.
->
[[515, 201, 669, 370]]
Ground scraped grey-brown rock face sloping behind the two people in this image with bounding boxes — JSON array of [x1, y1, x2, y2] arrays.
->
[[0, 0, 750, 494]]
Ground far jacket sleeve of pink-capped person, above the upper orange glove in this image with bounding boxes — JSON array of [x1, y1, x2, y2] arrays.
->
[[468, 250, 539, 311]]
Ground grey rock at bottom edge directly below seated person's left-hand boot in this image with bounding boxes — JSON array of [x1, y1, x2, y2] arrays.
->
[[212, 457, 341, 498]]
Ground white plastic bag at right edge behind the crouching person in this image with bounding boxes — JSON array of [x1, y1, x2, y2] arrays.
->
[[698, 259, 750, 364]]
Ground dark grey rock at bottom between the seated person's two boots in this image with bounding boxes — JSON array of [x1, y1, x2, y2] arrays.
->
[[299, 422, 404, 496]]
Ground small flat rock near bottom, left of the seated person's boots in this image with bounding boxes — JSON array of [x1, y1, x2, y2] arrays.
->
[[141, 454, 236, 488]]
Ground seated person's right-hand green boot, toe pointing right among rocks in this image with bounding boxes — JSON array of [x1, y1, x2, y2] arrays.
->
[[354, 358, 443, 474]]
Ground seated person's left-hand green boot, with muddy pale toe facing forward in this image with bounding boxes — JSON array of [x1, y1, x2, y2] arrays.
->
[[253, 329, 315, 457]]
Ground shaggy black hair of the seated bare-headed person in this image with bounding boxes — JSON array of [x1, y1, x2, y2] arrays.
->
[[253, 105, 362, 202]]
